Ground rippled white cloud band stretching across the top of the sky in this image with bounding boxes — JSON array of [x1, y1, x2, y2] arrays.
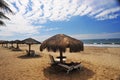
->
[[6, 0, 120, 24]]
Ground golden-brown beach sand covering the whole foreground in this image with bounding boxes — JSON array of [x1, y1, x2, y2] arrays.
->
[[0, 44, 120, 80]]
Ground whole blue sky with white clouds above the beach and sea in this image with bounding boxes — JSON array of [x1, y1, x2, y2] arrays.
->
[[0, 0, 120, 41]]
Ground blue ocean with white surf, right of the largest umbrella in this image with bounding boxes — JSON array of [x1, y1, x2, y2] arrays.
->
[[81, 38, 120, 47]]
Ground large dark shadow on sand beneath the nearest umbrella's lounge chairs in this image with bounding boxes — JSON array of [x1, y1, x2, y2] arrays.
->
[[44, 67, 95, 80]]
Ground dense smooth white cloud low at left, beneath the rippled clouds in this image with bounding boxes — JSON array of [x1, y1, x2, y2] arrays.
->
[[0, 14, 43, 36]]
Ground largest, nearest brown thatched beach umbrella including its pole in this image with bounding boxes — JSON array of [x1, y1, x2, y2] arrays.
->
[[40, 34, 83, 63]]
